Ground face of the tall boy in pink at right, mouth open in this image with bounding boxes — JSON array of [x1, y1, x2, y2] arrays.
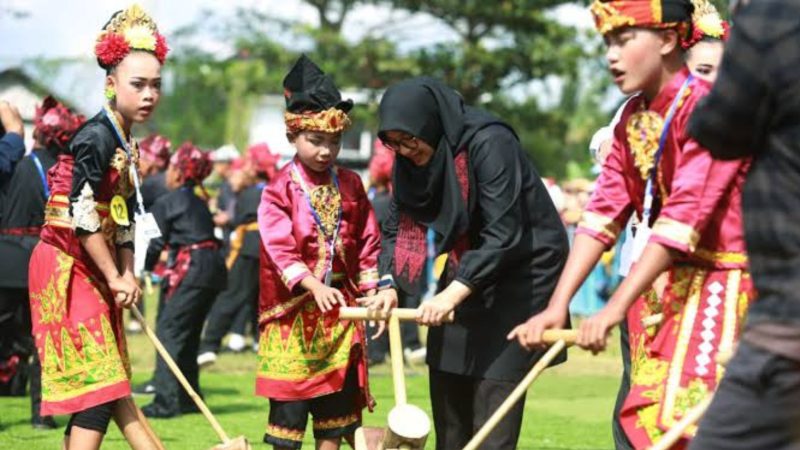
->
[[604, 28, 677, 98]]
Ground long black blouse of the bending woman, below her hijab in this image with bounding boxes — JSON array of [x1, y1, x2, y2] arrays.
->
[[380, 125, 569, 381]]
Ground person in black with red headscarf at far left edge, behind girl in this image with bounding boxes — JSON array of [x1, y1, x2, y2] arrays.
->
[[0, 96, 85, 429]]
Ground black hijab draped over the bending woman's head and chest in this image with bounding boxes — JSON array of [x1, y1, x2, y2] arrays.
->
[[378, 77, 507, 253]]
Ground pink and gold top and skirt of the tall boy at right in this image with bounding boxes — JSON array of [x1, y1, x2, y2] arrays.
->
[[577, 69, 755, 448]]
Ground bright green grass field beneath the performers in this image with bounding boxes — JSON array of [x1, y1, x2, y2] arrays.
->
[[0, 296, 620, 450]]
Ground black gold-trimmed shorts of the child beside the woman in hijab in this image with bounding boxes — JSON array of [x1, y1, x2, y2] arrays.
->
[[264, 364, 361, 448]]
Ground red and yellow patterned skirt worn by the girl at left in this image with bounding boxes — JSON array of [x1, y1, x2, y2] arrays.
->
[[29, 242, 130, 415]]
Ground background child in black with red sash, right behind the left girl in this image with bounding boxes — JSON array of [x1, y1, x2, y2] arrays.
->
[[142, 142, 227, 418]]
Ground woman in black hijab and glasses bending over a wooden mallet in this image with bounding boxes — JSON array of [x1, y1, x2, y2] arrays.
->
[[368, 77, 568, 449]]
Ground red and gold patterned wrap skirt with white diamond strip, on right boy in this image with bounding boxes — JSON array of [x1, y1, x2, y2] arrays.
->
[[620, 265, 755, 448]]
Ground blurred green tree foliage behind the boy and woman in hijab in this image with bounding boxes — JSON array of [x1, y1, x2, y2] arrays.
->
[[148, 0, 608, 177]]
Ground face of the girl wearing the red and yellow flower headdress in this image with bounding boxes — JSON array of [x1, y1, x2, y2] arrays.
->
[[106, 51, 161, 123]]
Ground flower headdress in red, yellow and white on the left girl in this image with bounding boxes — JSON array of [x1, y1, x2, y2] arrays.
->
[[94, 4, 169, 69]]
